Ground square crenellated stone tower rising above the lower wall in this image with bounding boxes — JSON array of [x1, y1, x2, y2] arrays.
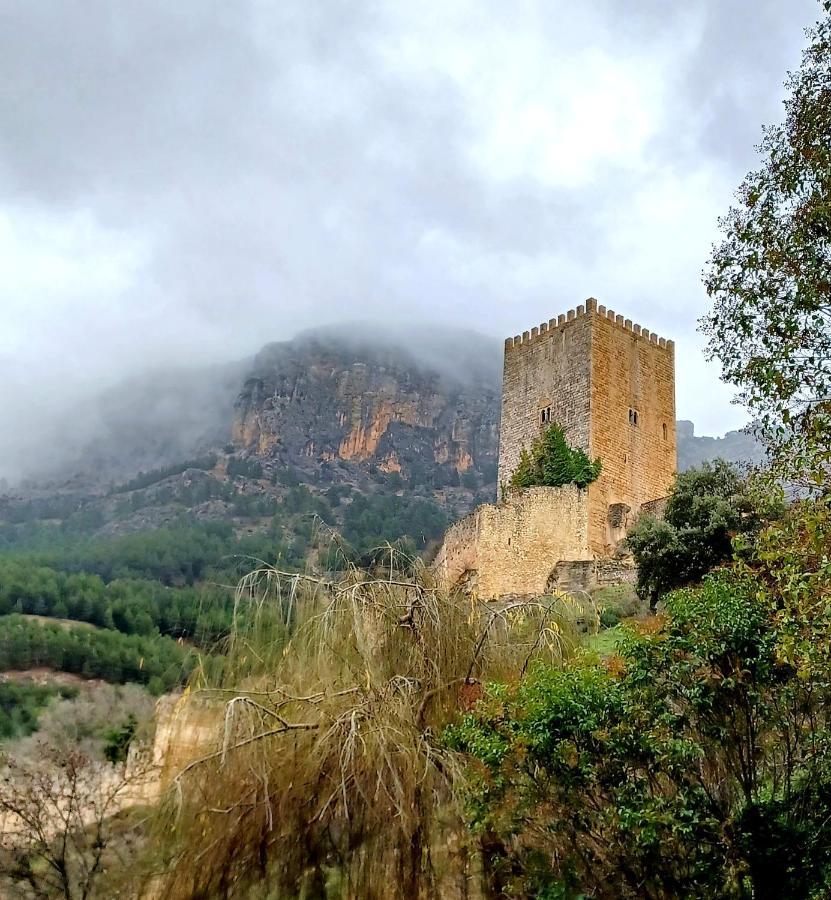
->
[[499, 299, 676, 556]]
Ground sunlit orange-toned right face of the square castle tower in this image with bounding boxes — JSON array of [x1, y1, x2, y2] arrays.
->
[[589, 306, 676, 554]]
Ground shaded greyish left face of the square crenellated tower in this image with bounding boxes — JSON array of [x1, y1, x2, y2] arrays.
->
[[498, 306, 592, 497]]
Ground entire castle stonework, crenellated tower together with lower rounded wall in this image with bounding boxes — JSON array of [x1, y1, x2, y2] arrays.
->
[[434, 299, 676, 598]]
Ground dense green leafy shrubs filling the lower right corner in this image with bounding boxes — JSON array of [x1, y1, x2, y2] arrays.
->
[[448, 544, 831, 900]]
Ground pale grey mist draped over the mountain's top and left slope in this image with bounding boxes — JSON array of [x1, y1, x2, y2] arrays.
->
[[0, 319, 501, 485]]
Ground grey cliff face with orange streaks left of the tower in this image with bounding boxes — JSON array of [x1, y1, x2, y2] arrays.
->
[[233, 338, 498, 482]]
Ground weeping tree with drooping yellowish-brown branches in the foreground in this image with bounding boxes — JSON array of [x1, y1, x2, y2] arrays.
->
[[146, 550, 585, 898]]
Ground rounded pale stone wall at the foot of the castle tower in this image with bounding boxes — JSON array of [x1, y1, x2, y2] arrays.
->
[[433, 485, 591, 599]]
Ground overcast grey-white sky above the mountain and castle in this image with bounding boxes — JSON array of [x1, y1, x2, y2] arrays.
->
[[0, 0, 819, 478]]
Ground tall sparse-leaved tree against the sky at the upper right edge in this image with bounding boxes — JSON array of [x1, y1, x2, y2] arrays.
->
[[702, 3, 831, 483]]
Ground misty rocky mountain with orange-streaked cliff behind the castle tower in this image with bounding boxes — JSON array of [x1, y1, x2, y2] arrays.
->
[[0, 323, 761, 546]]
